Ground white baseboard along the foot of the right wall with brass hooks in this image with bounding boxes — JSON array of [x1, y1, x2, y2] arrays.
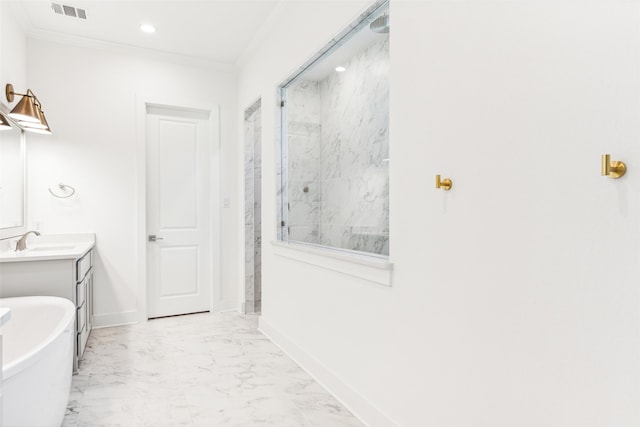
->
[[258, 315, 397, 427]]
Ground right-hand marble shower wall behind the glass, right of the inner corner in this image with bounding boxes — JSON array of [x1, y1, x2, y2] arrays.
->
[[320, 36, 389, 254]]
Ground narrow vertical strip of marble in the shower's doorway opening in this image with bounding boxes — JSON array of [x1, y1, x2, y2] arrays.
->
[[244, 101, 262, 313]]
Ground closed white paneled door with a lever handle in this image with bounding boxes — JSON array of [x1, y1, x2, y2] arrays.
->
[[146, 106, 211, 318]]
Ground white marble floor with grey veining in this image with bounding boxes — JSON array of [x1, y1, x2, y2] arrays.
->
[[63, 312, 362, 427]]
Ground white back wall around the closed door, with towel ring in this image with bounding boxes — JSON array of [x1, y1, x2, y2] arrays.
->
[[27, 39, 242, 325]]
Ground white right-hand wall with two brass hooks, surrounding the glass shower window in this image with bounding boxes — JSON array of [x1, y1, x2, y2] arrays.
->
[[236, 0, 640, 427]]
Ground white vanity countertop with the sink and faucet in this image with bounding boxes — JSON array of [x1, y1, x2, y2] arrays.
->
[[0, 233, 96, 263]]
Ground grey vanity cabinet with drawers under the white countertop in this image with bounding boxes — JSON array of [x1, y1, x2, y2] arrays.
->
[[0, 247, 94, 373]]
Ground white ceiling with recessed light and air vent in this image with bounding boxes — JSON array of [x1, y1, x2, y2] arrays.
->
[[3, 0, 279, 65]]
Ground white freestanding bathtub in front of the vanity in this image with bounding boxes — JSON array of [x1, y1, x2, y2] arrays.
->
[[0, 296, 76, 427]]
